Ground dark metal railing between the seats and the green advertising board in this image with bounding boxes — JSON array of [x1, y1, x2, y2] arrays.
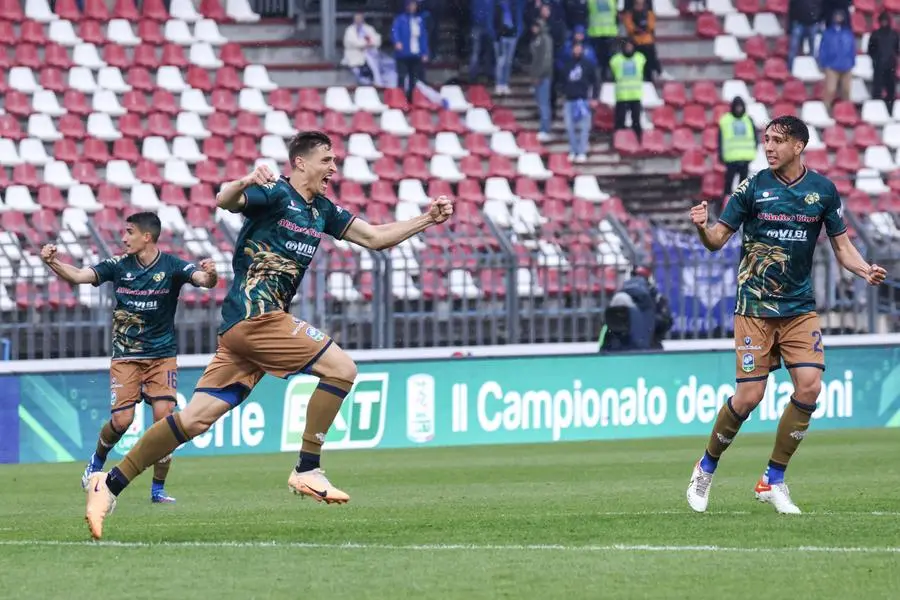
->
[[0, 209, 900, 359]]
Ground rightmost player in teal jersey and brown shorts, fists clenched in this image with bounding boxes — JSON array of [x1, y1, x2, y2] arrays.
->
[[687, 116, 886, 514]]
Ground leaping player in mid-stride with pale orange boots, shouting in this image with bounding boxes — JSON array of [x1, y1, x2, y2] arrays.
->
[[85, 131, 453, 539]]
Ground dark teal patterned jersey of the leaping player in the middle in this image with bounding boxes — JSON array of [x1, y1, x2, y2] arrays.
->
[[219, 177, 354, 333]]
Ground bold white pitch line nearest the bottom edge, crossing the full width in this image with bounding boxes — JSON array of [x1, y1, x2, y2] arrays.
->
[[0, 540, 900, 554]]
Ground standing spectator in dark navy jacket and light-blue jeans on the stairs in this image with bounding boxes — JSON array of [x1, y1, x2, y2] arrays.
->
[[562, 42, 599, 163]]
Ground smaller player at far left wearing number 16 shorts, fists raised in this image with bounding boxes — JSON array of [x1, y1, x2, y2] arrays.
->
[[41, 212, 218, 504]]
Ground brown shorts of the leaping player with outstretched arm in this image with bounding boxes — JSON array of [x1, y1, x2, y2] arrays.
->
[[194, 312, 332, 405]]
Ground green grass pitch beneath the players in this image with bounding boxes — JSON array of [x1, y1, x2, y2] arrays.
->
[[0, 430, 900, 600]]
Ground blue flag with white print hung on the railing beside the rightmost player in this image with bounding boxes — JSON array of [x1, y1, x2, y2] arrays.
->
[[653, 227, 741, 337]]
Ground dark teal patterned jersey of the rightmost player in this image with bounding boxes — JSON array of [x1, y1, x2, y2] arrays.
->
[[719, 169, 847, 317]]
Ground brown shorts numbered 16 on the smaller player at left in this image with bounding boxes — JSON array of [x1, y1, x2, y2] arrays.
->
[[109, 356, 178, 412]]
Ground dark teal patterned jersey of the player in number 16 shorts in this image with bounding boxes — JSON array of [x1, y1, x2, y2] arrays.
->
[[91, 252, 197, 359]]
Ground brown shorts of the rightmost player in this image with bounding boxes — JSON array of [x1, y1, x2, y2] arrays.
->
[[734, 312, 825, 382]]
